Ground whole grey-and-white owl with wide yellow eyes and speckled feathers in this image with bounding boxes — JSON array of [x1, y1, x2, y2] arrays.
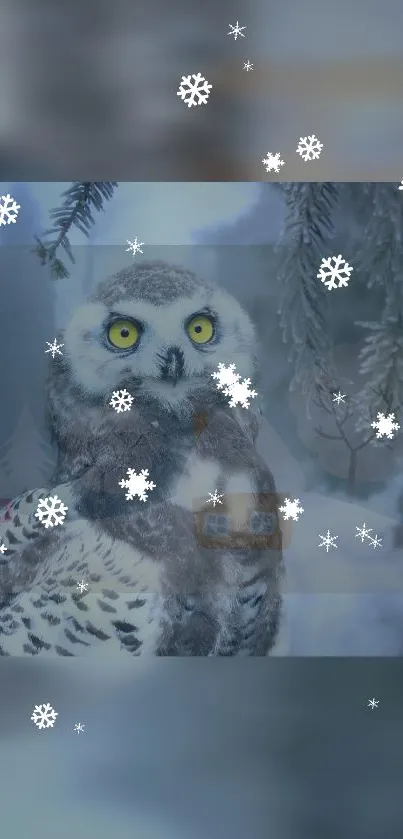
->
[[0, 262, 283, 656]]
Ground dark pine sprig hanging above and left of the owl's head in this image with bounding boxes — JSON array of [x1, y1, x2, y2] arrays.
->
[[34, 181, 117, 279]]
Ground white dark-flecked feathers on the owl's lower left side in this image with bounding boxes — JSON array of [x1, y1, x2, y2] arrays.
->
[[0, 520, 166, 657]]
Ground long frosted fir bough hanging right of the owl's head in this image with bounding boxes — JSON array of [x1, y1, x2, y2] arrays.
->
[[279, 183, 338, 413]]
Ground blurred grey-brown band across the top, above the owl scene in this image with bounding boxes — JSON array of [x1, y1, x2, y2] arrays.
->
[[0, 0, 403, 181]]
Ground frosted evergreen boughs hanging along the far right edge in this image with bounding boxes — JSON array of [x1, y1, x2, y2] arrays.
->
[[356, 184, 403, 427]]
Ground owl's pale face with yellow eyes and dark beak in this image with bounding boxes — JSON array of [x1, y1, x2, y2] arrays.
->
[[63, 260, 255, 406]]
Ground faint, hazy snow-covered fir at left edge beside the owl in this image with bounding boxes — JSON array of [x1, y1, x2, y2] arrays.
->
[[0, 406, 55, 498]]
